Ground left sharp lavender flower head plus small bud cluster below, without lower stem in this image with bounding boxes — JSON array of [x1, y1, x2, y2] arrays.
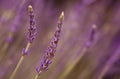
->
[[22, 5, 37, 55]]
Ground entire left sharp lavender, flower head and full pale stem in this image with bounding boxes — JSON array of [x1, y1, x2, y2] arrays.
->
[[9, 5, 36, 79]]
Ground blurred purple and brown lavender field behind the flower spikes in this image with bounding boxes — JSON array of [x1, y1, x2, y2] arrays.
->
[[0, 0, 120, 79]]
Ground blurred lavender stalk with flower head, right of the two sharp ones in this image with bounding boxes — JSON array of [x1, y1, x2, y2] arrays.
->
[[59, 25, 97, 79]]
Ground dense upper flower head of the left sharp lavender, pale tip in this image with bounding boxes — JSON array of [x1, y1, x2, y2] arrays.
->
[[27, 5, 37, 43]]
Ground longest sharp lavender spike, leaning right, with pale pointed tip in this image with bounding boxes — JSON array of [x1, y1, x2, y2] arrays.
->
[[34, 12, 64, 79]]
